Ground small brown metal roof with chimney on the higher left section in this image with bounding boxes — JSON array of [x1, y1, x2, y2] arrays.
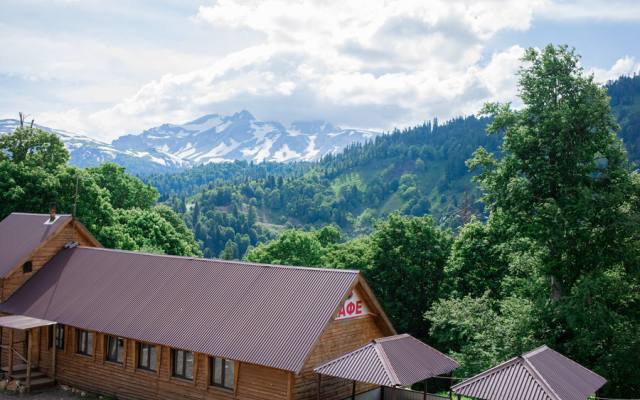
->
[[0, 213, 71, 278]]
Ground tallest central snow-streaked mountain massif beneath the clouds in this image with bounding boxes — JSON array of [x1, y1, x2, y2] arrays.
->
[[112, 110, 379, 164]]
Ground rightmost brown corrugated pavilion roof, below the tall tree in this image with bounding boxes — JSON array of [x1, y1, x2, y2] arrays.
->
[[451, 346, 607, 400]]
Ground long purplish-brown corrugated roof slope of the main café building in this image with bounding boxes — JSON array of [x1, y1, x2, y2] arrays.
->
[[0, 246, 358, 371]]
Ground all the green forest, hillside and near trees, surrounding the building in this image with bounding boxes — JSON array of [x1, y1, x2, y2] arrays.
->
[[5, 45, 640, 398]]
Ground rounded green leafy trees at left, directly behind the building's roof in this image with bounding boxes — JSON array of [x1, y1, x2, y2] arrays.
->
[[0, 127, 201, 256]]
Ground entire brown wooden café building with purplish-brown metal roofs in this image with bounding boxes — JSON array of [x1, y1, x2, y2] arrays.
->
[[0, 213, 396, 400]]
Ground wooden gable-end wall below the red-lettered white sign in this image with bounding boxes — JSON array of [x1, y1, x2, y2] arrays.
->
[[293, 296, 385, 400]]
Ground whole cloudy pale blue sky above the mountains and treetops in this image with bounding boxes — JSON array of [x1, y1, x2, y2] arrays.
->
[[0, 0, 640, 142]]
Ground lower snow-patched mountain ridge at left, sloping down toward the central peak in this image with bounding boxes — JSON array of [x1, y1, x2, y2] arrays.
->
[[0, 119, 193, 175]]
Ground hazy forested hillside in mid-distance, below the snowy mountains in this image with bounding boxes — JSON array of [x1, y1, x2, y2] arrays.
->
[[141, 116, 500, 259]]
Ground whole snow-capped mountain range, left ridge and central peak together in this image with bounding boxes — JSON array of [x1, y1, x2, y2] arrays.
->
[[0, 110, 380, 176]]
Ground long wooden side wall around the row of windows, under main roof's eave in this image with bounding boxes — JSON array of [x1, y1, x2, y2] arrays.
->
[[18, 327, 289, 400]]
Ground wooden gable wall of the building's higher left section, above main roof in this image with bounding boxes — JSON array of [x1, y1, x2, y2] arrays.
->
[[1, 222, 95, 301]]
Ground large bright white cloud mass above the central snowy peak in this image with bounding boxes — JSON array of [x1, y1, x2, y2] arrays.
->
[[90, 0, 546, 140]]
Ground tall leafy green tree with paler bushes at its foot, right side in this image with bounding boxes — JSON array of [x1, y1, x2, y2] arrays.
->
[[427, 46, 640, 397]]
